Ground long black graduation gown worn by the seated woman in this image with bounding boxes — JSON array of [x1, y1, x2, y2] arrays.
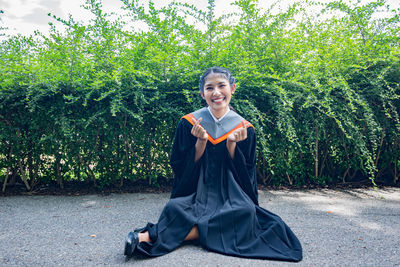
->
[[138, 110, 302, 261]]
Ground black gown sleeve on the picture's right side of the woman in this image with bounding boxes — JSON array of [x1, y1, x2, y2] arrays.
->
[[227, 127, 258, 205]]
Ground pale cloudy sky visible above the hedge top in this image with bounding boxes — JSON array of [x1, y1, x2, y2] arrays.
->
[[0, 0, 400, 38]]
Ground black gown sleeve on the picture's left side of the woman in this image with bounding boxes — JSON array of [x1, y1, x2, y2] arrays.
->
[[170, 119, 202, 198]]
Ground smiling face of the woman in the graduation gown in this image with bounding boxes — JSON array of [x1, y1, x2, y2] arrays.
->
[[201, 73, 236, 118]]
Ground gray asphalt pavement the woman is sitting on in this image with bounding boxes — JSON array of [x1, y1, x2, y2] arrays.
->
[[0, 188, 400, 266]]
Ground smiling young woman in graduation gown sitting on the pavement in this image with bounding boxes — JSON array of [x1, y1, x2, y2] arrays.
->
[[125, 67, 302, 261]]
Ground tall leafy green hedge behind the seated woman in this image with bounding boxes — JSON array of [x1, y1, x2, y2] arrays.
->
[[0, 0, 400, 193]]
